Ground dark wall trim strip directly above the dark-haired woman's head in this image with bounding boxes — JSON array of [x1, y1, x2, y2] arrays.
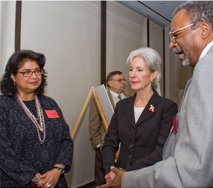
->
[[15, 1, 22, 51]]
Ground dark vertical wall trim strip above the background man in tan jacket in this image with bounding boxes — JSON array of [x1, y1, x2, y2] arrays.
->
[[101, 1, 107, 84]]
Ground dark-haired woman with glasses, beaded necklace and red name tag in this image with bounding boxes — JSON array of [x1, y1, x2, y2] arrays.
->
[[0, 50, 73, 188]]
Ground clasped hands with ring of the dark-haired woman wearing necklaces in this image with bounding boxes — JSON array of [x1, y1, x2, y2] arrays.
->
[[37, 168, 61, 188]]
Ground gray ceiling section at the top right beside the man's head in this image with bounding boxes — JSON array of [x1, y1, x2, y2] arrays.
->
[[122, 0, 184, 27]]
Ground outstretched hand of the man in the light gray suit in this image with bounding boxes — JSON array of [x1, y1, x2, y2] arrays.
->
[[97, 166, 126, 188]]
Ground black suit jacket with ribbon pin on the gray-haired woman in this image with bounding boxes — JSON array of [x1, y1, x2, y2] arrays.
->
[[103, 91, 177, 174]]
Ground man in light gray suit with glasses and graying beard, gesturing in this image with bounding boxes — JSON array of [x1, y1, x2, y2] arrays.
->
[[98, 1, 213, 188]]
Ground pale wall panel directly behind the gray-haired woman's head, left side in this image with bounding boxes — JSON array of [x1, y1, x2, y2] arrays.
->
[[106, 2, 147, 94]]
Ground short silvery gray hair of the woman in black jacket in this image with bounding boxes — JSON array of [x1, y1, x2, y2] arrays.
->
[[126, 47, 161, 90]]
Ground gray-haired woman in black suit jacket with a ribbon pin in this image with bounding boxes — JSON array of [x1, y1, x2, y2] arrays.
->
[[103, 48, 177, 183]]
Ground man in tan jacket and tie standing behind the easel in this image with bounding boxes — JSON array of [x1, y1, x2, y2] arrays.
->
[[89, 71, 129, 186]]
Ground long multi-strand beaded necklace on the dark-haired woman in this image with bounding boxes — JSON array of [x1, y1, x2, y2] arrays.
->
[[15, 94, 46, 144]]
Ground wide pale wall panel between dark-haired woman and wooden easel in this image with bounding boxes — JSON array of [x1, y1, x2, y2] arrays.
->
[[21, 1, 100, 187]]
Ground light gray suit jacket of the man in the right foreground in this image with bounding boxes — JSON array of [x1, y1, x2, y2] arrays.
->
[[122, 47, 213, 188]]
